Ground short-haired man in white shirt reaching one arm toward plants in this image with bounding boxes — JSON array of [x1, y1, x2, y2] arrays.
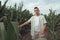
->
[[18, 7, 47, 40]]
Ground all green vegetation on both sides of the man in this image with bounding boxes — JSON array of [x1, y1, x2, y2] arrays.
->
[[0, 0, 60, 40]]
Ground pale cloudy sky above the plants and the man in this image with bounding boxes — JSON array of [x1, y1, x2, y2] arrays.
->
[[0, 0, 60, 14]]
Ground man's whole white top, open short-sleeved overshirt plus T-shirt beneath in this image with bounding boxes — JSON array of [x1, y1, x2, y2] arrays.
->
[[28, 15, 47, 35]]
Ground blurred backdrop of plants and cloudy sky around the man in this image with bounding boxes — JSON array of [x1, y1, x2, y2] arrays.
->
[[0, 0, 60, 40]]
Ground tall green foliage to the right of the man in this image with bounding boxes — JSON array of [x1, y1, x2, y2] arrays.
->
[[45, 9, 60, 40]]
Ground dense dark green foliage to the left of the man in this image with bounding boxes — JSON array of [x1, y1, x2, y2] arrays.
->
[[0, 0, 32, 40]]
